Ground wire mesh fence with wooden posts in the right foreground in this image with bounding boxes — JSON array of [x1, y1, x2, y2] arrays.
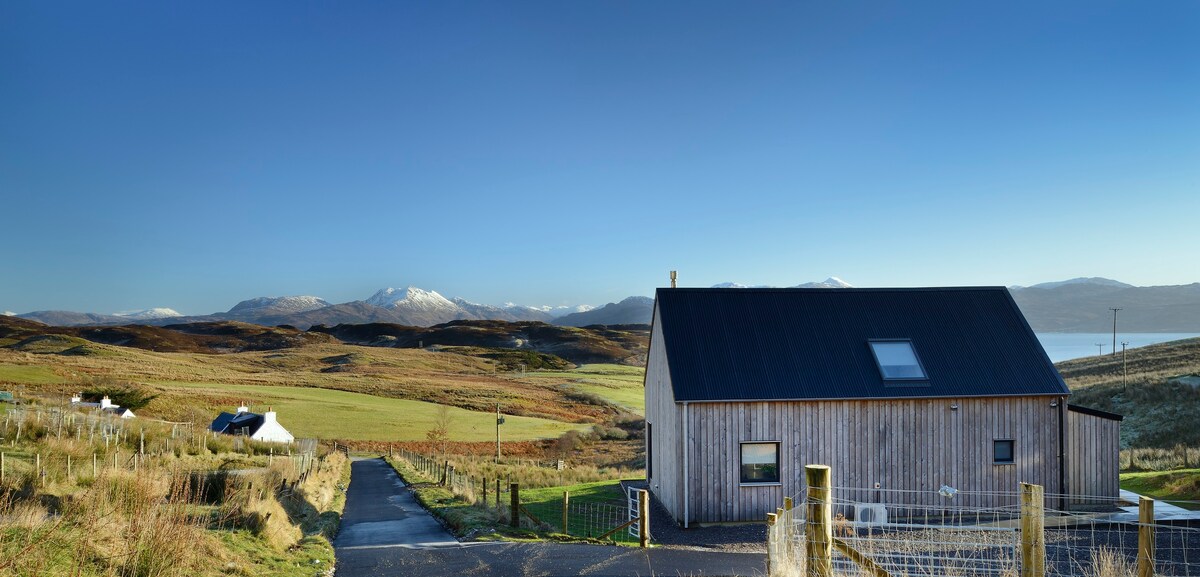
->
[[767, 463, 1200, 577]]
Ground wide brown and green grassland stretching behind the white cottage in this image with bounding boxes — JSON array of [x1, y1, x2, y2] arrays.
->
[[0, 342, 642, 441]]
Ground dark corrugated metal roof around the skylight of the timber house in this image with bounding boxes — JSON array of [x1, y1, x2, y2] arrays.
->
[[654, 287, 1069, 402]]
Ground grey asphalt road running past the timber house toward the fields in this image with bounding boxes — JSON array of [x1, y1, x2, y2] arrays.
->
[[334, 459, 766, 577]]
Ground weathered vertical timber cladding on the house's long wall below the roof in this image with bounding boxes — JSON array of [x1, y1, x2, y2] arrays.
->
[[681, 397, 1062, 523]]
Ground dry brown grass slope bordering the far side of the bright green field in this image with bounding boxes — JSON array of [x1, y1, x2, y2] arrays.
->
[[0, 344, 628, 422]]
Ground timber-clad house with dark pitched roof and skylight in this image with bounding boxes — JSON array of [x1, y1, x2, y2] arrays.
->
[[646, 287, 1117, 527]]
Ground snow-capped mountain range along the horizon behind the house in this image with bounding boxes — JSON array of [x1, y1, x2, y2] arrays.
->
[[5, 277, 1200, 332]]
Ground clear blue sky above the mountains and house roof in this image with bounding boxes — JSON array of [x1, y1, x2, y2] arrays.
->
[[0, 0, 1200, 314]]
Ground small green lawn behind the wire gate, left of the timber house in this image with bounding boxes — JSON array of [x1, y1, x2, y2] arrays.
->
[[521, 481, 637, 542]]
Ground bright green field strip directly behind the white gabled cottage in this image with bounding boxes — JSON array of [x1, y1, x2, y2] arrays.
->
[[152, 381, 588, 441]]
